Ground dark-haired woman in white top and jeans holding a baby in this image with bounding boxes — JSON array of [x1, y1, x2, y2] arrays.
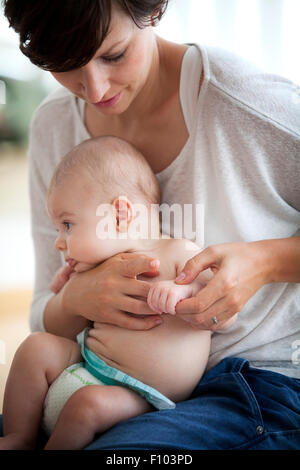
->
[[4, 0, 300, 449]]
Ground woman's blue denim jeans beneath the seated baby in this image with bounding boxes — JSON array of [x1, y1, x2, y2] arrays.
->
[[0, 358, 300, 450]]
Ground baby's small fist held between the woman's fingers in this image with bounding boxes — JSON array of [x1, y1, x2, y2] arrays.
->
[[147, 281, 193, 315]]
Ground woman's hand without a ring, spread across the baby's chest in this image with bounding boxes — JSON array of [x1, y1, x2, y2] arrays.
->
[[61, 253, 162, 330]]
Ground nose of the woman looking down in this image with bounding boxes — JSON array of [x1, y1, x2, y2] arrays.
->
[[81, 62, 110, 103]]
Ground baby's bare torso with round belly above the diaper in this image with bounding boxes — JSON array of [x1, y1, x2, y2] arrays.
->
[[86, 244, 210, 401]]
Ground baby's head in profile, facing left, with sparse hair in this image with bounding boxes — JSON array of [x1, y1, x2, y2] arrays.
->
[[47, 136, 160, 271]]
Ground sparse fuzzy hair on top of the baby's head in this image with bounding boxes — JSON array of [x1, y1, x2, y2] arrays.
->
[[48, 136, 160, 205]]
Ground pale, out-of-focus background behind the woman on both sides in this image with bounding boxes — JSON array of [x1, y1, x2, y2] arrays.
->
[[0, 0, 300, 412]]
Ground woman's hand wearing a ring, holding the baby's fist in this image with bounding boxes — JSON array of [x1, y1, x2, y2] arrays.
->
[[176, 240, 272, 330]]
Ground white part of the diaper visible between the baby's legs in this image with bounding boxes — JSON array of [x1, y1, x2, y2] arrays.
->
[[41, 363, 105, 435]]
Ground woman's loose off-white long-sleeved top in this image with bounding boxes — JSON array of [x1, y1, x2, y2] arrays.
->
[[29, 45, 300, 378]]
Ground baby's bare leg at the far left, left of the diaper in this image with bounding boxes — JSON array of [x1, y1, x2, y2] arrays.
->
[[0, 333, 81, 449]]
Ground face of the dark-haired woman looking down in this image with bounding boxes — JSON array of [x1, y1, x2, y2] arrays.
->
[[52, 7, 155, 114]]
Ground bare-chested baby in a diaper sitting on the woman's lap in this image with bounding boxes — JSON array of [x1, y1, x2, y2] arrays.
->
[[0, 137, 232, 449]]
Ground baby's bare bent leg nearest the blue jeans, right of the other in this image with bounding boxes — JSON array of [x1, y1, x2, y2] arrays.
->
[[45, 385, 153, 450]]
